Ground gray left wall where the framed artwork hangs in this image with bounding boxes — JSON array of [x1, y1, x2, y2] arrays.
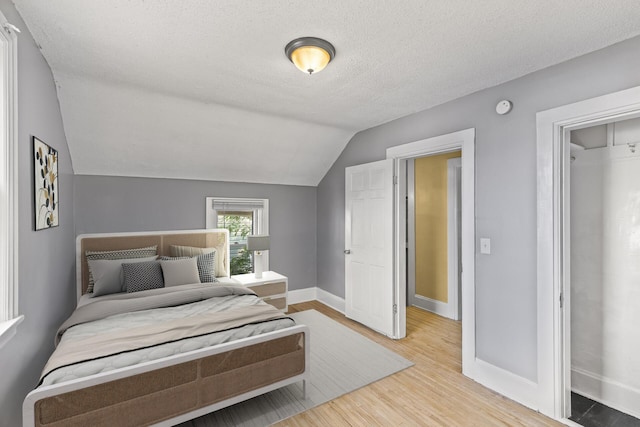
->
[[0, 0, 75, 426]]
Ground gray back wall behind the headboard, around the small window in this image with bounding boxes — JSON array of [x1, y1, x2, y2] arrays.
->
[[75, 175, 316, 289]]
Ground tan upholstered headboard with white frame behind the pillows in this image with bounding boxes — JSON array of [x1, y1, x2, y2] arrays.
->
[[76, 228, 230, 299]]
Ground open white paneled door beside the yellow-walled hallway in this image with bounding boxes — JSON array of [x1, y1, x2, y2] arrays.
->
[[345, 159, 394, 337]]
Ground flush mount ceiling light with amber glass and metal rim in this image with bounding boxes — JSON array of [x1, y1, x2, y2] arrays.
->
[[284, 37, 336, 74]]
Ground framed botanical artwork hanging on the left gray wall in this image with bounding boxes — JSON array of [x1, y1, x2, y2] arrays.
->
[[31, 136, 60, 231]]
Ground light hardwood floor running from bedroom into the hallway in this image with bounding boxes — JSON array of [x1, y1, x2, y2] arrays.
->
[[276, 301, 562, 427]]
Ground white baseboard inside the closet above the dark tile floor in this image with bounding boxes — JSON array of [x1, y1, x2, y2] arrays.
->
[[571, 367, 640, 418]]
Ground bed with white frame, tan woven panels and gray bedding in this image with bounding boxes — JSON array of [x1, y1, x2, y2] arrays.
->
[[23, 229, 310, 427]]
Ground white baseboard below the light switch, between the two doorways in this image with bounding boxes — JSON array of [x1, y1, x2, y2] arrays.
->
[[471, 358, 538, 411]]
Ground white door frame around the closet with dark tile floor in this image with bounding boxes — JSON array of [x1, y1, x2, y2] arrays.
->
[[536, 86, 640, 420]]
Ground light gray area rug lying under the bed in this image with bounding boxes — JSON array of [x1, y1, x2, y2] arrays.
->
[[180, 310, 413, 427]]
